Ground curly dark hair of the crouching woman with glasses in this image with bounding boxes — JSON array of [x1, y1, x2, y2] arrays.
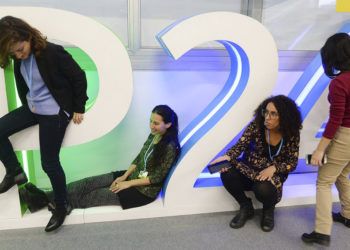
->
[[254, 95, 302, 139]]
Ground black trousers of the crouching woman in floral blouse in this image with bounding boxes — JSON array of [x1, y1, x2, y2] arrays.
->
[[220, 168, 277, 210]]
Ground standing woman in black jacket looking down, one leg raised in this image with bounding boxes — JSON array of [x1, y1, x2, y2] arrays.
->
[[0, 16, 88, 232]]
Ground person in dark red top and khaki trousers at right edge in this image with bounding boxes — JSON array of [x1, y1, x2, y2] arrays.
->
[[302, 33, 350, 246]]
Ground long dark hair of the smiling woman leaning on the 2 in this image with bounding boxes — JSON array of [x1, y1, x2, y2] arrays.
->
[[152, 105, 181, 166]]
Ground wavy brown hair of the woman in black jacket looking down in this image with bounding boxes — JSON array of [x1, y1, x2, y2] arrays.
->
[[0, 16, 47, 68]]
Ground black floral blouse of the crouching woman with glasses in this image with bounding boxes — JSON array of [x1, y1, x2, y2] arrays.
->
[[226, 121, 300, 202]]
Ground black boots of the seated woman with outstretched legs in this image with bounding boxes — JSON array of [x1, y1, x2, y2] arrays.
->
[[19, 182, 49, 213]]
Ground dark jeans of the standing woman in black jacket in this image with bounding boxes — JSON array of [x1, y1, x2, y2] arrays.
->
[[0, 106, 70, 208]]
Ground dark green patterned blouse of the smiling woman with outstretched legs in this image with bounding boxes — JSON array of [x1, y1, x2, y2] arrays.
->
[[127, 134, 177, 198]]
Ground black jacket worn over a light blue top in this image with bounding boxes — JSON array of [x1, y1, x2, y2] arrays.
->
[[14, 42, 88, 114]]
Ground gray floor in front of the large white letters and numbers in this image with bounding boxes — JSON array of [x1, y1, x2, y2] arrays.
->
[[0, 204, 350, 250]]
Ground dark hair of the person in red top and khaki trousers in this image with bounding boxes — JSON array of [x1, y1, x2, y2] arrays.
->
[[321, 33, 350, 78]]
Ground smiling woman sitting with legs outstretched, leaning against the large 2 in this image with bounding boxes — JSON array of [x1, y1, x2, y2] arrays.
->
[[20, 105, 181, 229]]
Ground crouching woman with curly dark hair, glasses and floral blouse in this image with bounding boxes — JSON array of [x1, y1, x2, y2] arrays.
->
[[212, 95, 302, 232]]
